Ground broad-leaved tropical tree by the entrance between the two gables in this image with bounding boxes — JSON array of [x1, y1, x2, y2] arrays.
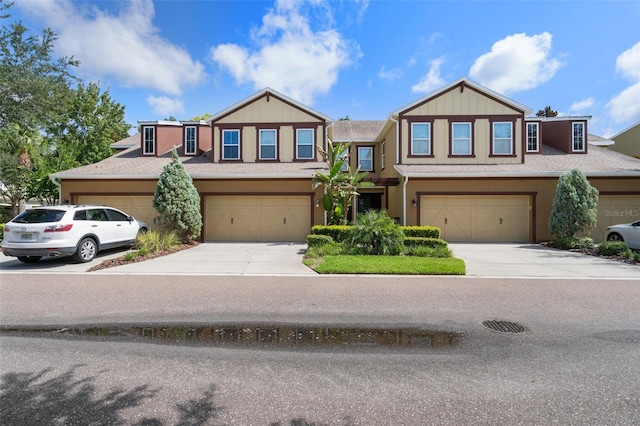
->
[[313, 139, 372, 225]]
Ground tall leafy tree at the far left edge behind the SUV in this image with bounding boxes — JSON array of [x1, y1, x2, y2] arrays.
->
[[0, 0, 78, 214]]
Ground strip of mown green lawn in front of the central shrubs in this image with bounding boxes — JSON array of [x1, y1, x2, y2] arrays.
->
[[305, 255, 466, 275]]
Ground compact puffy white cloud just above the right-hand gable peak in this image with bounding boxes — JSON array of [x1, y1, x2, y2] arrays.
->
[[469, 32, 562, 94]]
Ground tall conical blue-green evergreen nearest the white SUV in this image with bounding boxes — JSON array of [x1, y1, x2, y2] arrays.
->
[[153, 149, 202, 241]]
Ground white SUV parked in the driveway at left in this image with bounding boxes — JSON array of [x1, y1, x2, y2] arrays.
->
[[2, 205, 148, 263]]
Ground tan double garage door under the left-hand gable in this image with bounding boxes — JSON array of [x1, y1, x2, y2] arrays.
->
[[205, 195, 311, 241]]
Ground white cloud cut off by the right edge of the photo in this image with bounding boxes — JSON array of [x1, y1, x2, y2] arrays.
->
[[607, 42, 640, 124]]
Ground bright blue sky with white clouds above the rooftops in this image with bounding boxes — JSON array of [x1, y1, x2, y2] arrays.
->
[[10, 0, 640, 136]]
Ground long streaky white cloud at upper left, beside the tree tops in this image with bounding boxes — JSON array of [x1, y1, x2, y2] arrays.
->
[[17, 0, 205, 95]]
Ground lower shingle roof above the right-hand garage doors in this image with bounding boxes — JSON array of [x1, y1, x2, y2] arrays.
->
[[395, 145, 640, 177]]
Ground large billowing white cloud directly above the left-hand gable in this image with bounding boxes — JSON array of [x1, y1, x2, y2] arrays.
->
[[211, 1, 358, 105]]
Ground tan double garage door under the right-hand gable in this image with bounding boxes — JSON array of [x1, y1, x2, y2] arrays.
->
[[420, 195, 530, 242]]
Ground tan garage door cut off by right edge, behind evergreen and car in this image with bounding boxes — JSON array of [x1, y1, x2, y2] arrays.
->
[[591, 195, 640, 242]]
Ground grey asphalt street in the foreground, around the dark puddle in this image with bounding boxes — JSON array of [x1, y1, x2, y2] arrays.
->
[[0, 274, 640, 426]]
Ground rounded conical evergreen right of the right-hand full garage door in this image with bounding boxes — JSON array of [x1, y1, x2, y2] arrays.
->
[[549, 169, 598, 238]]
